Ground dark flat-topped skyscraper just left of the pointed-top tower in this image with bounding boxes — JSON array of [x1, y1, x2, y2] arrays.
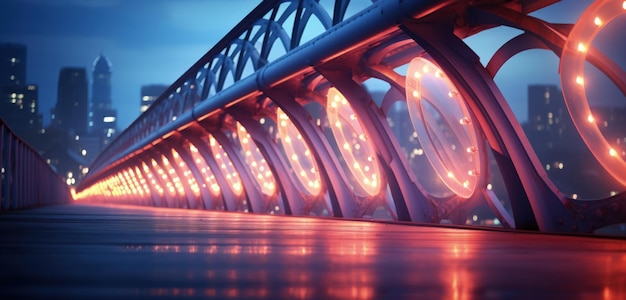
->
[[51, 68, 87, 134]]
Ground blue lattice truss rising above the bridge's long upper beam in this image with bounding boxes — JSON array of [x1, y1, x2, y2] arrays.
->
[[86, 0, 367, 179]]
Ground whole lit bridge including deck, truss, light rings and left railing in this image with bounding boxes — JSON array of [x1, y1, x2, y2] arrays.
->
[[0, 0, 626, 299]]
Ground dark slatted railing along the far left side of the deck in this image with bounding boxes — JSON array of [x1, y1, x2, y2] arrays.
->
[[0, 119, 72, 211]]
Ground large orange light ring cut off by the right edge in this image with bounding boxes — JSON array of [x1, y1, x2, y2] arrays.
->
[[560, 0, 626, 186]]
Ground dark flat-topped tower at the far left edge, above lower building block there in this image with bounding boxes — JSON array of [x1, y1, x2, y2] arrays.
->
[[0, 44, 26, 87]]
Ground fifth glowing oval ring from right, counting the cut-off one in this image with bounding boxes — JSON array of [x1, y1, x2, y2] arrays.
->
[[237, 122, 276, 196]]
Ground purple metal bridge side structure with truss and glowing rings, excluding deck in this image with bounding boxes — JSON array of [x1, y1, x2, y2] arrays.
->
[[76, 0, 626, 232]]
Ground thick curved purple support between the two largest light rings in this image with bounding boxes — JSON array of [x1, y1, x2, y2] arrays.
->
[[404, 23, 552, 230]]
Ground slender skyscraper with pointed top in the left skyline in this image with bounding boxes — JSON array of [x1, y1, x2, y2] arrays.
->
[[89, 54, 117, 145]]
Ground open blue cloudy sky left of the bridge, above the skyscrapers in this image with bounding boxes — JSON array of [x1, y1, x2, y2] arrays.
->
[[0, 0, 260, 130]]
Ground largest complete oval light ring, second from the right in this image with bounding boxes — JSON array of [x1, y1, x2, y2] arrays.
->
[[405, 57, 482, 199]]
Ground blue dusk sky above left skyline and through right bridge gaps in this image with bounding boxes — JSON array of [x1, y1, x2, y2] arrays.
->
[[0, 0, 624, 129]]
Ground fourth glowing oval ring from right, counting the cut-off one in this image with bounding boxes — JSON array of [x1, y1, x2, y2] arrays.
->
[[276, 108, 322, 196]]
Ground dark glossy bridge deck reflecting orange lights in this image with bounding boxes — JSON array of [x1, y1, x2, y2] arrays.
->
[[0, 205, 626, 299]]
